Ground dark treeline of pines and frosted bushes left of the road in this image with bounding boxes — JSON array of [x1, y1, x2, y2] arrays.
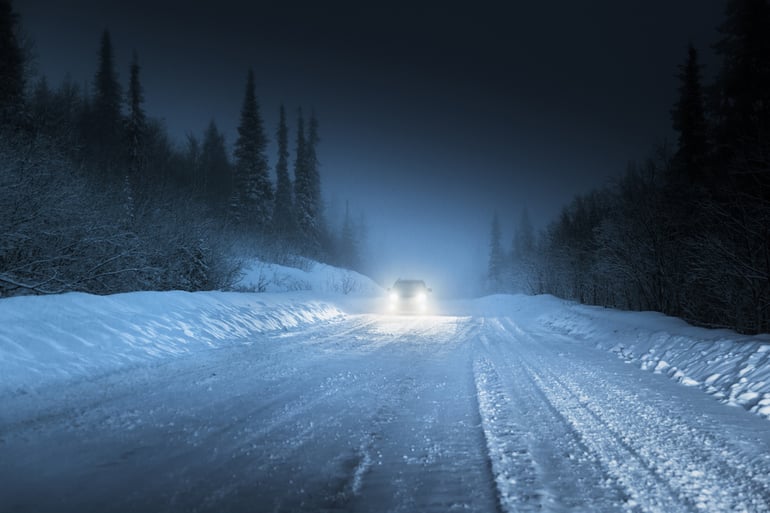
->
[[0, 0, 359, 297]]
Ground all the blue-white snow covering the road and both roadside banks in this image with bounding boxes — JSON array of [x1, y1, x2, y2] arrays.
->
[[0, 276, 770, 513]]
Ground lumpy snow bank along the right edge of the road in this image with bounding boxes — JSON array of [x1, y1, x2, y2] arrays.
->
[[532, 296, 770, 419]]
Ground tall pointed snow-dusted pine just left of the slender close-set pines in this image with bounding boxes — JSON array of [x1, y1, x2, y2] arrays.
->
[[232, 70, 273, 231]]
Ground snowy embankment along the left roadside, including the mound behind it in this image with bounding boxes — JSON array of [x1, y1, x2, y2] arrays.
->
[[0, 264, 377, 395]]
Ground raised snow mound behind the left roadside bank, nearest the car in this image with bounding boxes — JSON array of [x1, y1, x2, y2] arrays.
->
[[235, 259, 383, 296]]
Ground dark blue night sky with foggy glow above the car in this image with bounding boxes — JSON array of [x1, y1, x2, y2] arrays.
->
[[14, 0, 724, 292]]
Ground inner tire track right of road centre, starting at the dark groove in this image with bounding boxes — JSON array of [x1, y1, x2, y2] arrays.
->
[[474, 320, 633, 513]]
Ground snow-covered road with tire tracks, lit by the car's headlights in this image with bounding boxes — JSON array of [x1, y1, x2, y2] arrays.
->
[[0, 306, 770, 513]]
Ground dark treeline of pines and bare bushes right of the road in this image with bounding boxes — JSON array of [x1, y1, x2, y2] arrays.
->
[[489, 0, 770, 333]]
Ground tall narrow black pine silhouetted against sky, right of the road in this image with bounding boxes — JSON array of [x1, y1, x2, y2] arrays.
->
[[671, 45, 708, 184]]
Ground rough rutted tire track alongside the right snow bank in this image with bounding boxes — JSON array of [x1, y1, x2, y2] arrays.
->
[[500, 319, 770, 513]]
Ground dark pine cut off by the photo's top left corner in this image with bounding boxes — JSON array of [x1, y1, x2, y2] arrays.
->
[[0, 0, 24, 128]]
